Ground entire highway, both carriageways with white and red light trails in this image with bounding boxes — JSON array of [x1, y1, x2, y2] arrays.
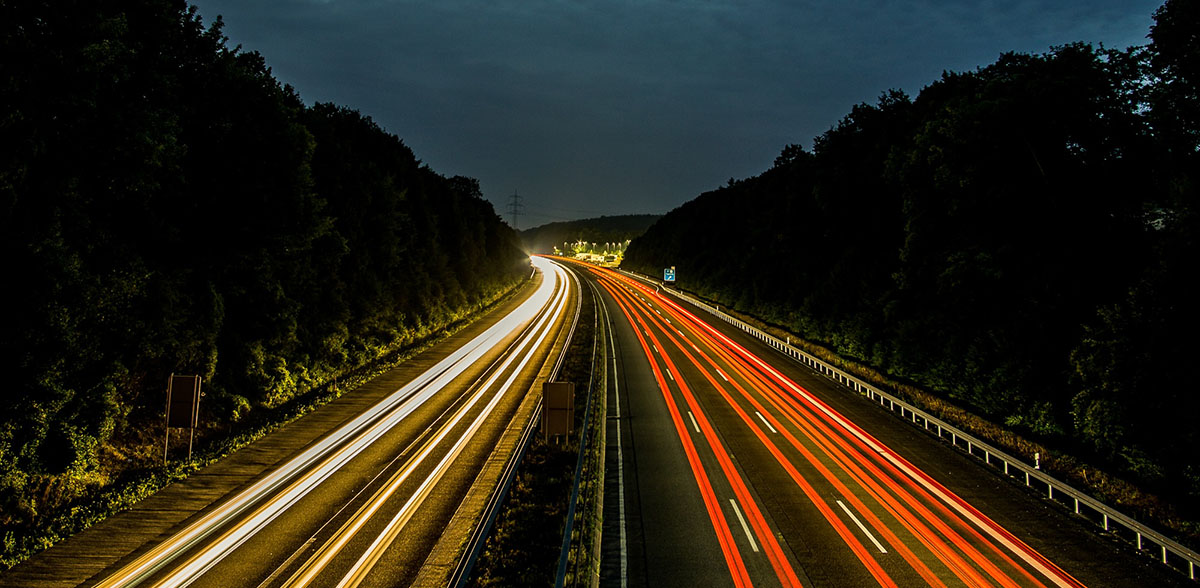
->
[[9, 258, 1192, 588]]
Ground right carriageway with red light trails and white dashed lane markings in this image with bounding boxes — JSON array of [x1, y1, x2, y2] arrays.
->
[[574, 265, 1184, 588]]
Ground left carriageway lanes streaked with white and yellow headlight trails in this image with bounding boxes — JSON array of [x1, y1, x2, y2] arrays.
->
[[4, 259, 578, 588]]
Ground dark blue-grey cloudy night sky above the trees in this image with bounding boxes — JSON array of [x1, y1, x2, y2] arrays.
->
[[192, 0, 1162, 229]]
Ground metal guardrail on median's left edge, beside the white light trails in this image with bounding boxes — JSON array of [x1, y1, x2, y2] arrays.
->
[[446, 267, 583, 588]]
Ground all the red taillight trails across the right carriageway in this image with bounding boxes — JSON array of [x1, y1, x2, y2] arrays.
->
[[573, 260, 1082, 588]]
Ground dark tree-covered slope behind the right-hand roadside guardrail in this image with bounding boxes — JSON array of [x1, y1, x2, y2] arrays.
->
[[624, 0, 1200, 520]]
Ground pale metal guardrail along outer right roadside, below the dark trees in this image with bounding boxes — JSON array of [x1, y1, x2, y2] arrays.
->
[[620, 270, 1200, 580]]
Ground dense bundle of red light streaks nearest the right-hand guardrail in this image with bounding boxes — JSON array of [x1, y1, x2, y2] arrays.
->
[[595, 266, 1081, 587]]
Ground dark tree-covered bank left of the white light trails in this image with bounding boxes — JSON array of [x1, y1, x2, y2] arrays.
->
[[0, 0, 529, 548]]
